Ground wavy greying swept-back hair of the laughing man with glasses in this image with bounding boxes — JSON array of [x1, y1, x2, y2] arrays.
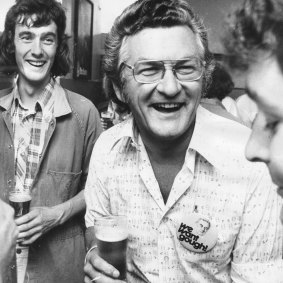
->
[[103, 0, 214, 113]]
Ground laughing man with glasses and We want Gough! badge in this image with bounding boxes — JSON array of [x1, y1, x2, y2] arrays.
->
[[84, 0, 282, 283]]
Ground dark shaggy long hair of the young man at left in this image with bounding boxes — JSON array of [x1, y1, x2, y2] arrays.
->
[[0, 0, 71, 77]]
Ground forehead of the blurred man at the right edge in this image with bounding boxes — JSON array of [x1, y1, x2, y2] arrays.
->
[[246, 57, 283, 119]]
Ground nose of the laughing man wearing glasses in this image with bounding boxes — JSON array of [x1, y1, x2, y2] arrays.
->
[[157, 68, 181, 96]]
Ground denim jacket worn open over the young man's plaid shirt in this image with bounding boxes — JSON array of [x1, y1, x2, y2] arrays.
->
[[0, 84, 102, 283]]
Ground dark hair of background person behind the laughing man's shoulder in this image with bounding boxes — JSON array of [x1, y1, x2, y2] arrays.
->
[[206, 63, 234, 100]]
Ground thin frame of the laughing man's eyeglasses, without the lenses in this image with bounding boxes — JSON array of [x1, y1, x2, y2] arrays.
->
[[120, 57, 206, 84]]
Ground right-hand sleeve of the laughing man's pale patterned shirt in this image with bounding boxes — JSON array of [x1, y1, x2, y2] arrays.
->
[[231, 164, 283, 283]]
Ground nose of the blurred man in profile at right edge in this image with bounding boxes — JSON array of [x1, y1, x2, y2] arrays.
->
[[246, 115, 270, 163]]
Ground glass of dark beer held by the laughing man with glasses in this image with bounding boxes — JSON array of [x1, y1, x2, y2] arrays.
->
[[94, 215, 128, 279]]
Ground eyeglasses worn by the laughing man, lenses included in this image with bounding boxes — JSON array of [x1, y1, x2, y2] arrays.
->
[[123, 57, 205, 84]]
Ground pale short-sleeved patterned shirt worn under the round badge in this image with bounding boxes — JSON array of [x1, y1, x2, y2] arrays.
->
[[85, 106, 283, 283]]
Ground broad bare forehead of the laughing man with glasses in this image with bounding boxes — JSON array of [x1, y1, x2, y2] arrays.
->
[[124, 26, 201, 63]]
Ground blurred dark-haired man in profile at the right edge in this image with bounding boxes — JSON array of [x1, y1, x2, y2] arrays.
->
[[225, 0, 283, 224]]
